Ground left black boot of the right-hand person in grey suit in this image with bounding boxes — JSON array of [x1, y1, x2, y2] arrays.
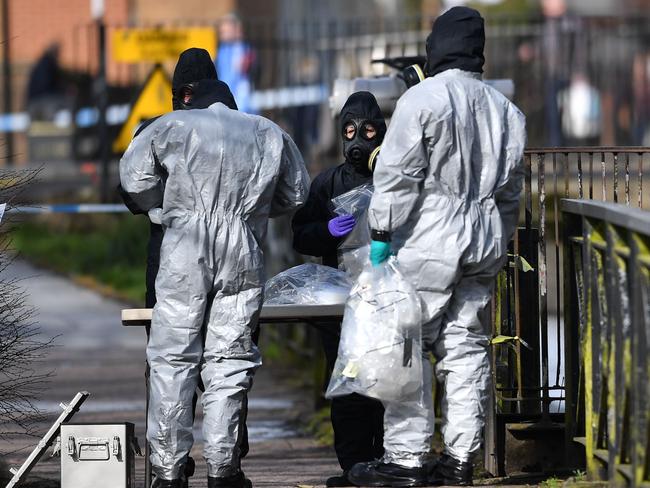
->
[[348, 461, 427, 487]]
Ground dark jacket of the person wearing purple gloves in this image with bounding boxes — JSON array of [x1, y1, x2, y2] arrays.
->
[[291, 162, 372, 268]]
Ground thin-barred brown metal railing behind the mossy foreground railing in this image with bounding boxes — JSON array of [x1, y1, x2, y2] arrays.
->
[[485, 147, 650, 475]]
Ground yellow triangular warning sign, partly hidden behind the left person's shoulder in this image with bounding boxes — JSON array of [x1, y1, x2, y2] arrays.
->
[[113, 66, 172, 152]]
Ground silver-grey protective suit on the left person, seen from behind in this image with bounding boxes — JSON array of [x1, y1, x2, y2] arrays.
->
[[120, 103, 309, 479]]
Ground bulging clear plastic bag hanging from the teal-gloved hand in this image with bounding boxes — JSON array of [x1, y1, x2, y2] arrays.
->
[[325, 257, 423, 403]]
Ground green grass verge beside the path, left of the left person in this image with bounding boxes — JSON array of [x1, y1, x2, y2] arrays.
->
[[12, 215, 149, 304]]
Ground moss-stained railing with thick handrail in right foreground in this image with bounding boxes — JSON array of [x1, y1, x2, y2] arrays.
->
[[562, 200, 650, 486]]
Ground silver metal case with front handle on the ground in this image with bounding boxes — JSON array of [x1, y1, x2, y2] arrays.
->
[[61, 422, 137, 488]]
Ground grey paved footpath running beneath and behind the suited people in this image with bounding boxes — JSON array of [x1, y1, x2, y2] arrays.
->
[[0, 261, 339, 488]]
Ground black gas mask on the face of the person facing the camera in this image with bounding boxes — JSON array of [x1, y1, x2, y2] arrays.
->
[[341, 118, 383, 174]]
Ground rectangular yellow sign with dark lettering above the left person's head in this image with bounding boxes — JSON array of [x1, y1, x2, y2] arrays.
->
[[112, 27, 217, 63]]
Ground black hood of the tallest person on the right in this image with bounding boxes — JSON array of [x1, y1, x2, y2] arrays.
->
[[425, 7, 485, 76]]
